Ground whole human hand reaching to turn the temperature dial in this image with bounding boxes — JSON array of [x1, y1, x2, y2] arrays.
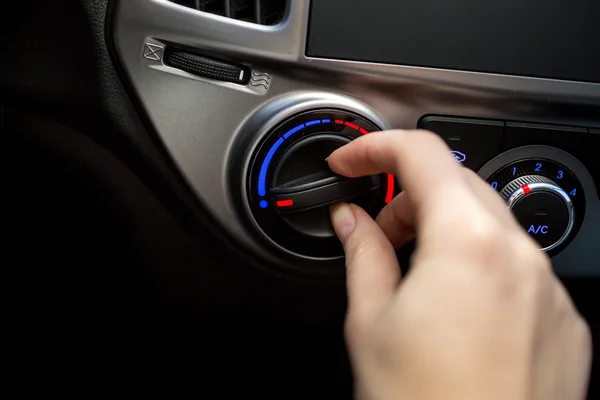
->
[[328, 131, 591, 400]]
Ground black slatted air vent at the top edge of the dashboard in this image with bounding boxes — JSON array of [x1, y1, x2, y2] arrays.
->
[[171, 0, 287, 25]]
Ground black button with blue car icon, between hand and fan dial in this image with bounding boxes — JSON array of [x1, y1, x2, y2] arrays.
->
[[419, 116, 504, 171]]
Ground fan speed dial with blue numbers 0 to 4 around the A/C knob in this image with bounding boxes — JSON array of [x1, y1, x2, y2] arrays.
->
[[488, 159, 585, 252]]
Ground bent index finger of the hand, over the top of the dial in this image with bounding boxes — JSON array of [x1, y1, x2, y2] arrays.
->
[[328, 130, 468, 223]]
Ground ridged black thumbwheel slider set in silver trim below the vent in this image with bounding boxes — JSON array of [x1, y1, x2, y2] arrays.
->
[[165, 49, 250, 84]]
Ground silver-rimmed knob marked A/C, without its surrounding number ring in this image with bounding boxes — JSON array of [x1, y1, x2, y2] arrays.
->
[[500, 175, 575, 251]]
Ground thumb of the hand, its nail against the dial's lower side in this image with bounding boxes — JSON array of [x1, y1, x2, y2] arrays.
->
[[331, 203, 400, 330]]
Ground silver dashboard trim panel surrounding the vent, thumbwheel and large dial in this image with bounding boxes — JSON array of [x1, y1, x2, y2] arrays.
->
[[113, 0, 600, 274]]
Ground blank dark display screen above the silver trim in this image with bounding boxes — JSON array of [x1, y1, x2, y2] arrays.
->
[[307, 0, 600, 83]]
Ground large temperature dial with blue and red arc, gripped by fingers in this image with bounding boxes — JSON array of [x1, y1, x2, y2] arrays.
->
[[246, 109, 397, 260]]
